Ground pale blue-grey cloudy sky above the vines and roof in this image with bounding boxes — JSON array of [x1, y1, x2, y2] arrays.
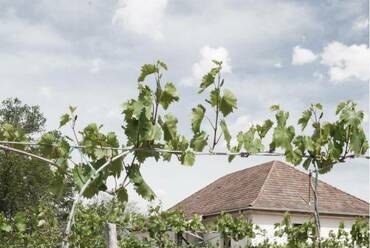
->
[[0, 0, 370, 208]]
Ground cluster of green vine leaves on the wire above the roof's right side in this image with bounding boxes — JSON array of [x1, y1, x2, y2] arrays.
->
[[270, 101, 368, 173]]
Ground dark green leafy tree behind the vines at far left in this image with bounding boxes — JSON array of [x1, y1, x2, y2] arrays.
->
[[0, 98, 71, 217]]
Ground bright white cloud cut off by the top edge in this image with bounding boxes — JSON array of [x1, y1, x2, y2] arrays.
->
[[112, 0, 167, 40]]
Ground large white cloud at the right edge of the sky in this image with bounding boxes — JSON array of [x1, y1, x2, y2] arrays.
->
[[321, 41, 370, 81]]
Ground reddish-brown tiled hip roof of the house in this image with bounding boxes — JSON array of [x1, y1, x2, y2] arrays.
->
[[170, 160, 369, 216]]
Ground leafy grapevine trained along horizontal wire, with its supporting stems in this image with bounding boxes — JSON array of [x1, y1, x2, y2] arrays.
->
[[0, 61, 369, 248]]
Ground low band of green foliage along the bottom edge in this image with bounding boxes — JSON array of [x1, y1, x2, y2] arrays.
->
[[0, 199, 369, 248]]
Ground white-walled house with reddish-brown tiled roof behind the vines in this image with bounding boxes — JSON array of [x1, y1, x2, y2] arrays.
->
[[171, 161, 369, 247]]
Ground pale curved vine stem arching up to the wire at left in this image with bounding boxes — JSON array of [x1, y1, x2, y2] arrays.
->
[[62, 152, 128, 248]]
